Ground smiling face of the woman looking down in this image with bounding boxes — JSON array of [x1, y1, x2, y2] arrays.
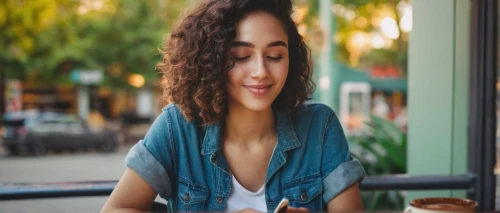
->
[[228, 12, 289, 111]]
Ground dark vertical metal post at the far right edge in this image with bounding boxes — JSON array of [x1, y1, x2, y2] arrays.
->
[[468, 0, 498, 211]]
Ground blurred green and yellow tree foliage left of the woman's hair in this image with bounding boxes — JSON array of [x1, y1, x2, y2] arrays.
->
[[0, 0, 187, 87]]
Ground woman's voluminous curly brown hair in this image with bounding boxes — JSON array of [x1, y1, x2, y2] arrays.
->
[[157, 0, 315, 125]]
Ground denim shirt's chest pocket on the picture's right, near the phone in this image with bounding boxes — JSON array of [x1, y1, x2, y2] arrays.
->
[[283, 174, 323, 211]]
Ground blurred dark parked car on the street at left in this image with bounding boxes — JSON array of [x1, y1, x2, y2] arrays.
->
[[2, 112, 117, 155]]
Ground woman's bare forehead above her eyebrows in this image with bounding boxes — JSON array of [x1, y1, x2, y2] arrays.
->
[[235, 12, 288, 46]]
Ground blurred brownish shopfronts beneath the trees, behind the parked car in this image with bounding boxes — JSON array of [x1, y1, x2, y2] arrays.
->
[[4, 70, 163, 128]]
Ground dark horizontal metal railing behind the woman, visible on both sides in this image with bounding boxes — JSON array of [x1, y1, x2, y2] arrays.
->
[[0, 175, 475, 201]]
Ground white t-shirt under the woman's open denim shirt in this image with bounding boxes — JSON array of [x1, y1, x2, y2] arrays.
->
[[226, 176, 267, 212]]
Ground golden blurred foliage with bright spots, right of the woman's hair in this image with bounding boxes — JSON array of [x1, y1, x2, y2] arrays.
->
[[296, 0, 408, 74]]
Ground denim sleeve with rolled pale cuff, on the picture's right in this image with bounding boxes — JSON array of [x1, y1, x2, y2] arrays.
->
[[321, 111, 365, 204]]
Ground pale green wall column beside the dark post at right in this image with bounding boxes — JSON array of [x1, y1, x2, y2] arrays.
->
[[407, 0, 470, 202]]
